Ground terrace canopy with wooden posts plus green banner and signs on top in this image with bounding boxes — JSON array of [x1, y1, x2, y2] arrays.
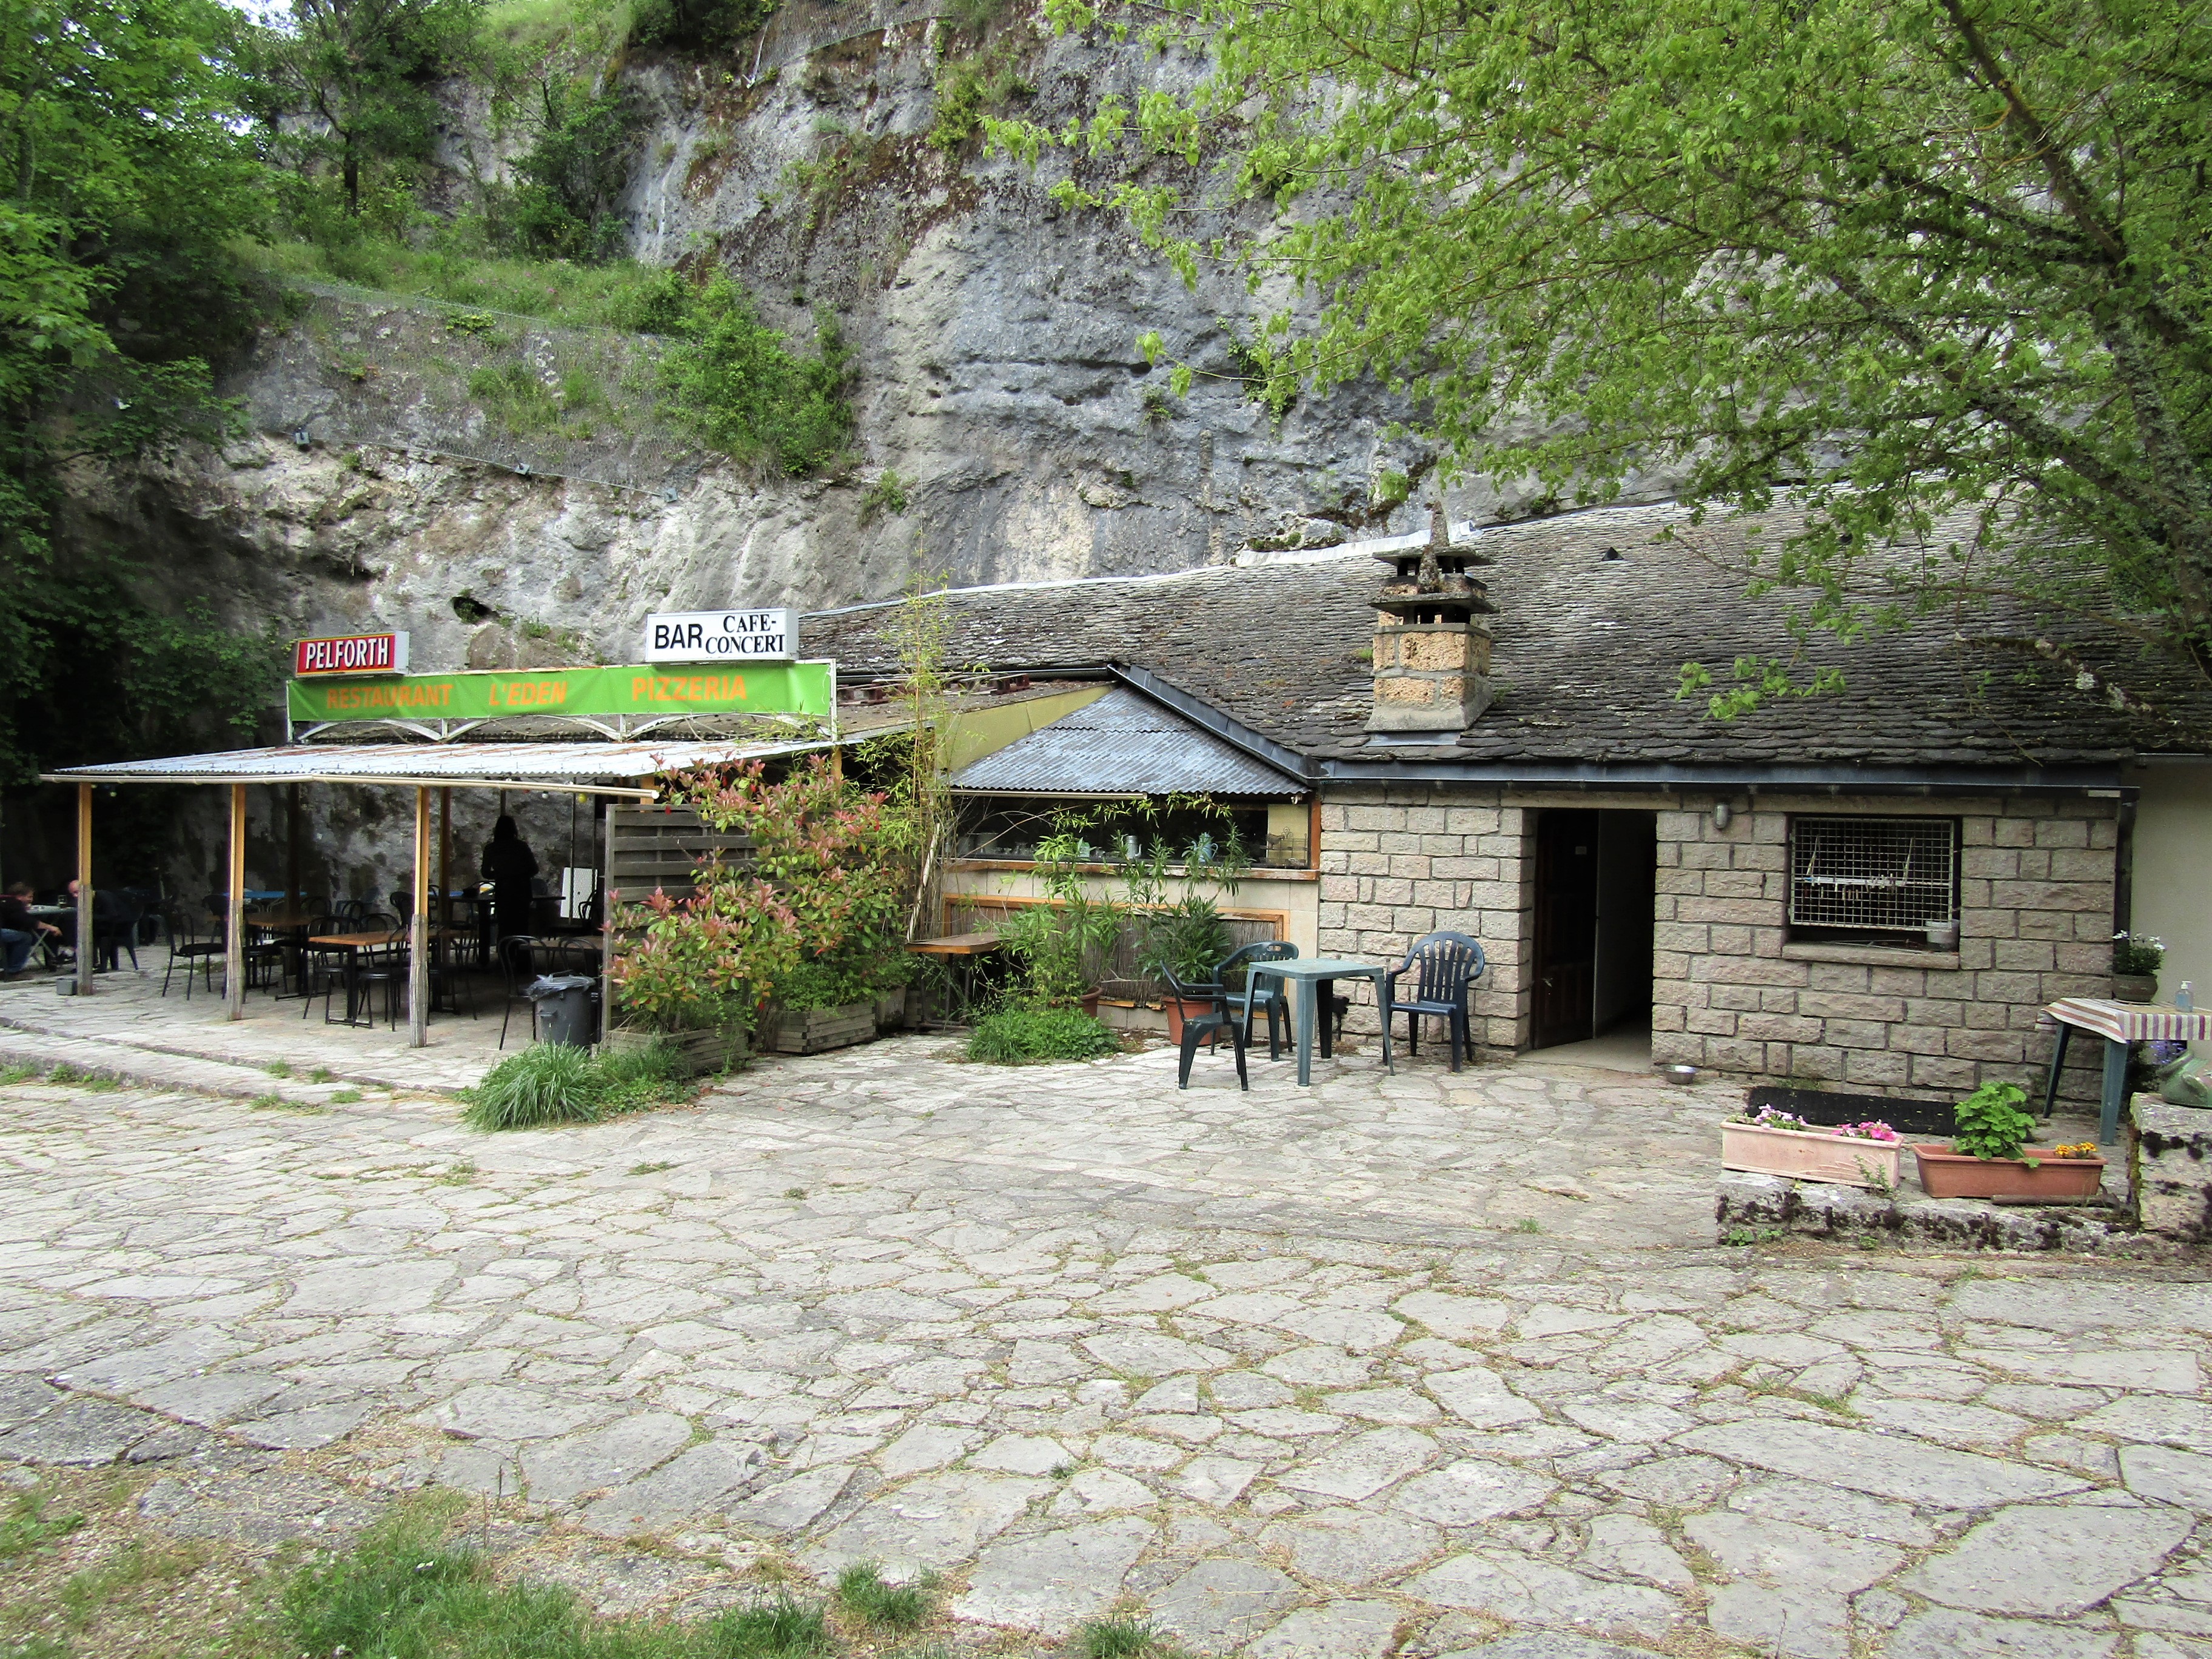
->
[[44, 611, 839, 1047]]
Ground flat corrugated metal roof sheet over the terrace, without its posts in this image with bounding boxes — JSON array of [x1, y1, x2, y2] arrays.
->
[[42, 739, 830, 799]]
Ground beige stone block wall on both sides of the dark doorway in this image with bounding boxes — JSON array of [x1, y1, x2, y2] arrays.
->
[[1318, 785, 2119, 1099]]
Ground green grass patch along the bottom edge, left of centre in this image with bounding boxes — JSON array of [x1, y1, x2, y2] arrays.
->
[[279, 1509, 830, 1659]]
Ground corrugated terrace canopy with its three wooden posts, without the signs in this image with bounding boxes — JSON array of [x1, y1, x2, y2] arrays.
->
[[42, 739, 834, 1048]]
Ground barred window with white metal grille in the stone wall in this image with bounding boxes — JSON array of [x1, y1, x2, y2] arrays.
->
[[1789, 819, 1957, 936]]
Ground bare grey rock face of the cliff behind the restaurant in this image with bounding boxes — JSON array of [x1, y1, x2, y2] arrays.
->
[[75, 18, 1657, 668]]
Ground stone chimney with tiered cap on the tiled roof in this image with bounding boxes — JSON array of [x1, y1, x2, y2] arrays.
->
[[1367, 502, 1493, 732]]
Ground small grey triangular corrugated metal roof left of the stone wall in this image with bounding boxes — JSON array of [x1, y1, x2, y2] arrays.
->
[[953, 686, 1305, 801]]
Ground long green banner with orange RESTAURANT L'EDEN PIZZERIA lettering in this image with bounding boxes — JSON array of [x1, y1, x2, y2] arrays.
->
[[290, 662, 836, 723]]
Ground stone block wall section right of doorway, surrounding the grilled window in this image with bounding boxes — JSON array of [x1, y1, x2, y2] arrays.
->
[[1652, 794, 2119, 1099]]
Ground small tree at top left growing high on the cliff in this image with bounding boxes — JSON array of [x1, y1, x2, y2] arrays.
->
[[246, 0, 484, 219]]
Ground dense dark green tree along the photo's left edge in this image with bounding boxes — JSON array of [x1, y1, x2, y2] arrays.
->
[[0, 0, 274, 783]]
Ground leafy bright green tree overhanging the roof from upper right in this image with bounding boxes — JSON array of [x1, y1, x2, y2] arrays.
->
[[989, 0, 2212, 714]]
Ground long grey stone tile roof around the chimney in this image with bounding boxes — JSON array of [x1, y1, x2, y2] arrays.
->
[[801, 506, 2212, 768]]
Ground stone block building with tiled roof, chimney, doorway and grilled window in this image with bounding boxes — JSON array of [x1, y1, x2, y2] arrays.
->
[[803, 506, 2212, 1095]]
